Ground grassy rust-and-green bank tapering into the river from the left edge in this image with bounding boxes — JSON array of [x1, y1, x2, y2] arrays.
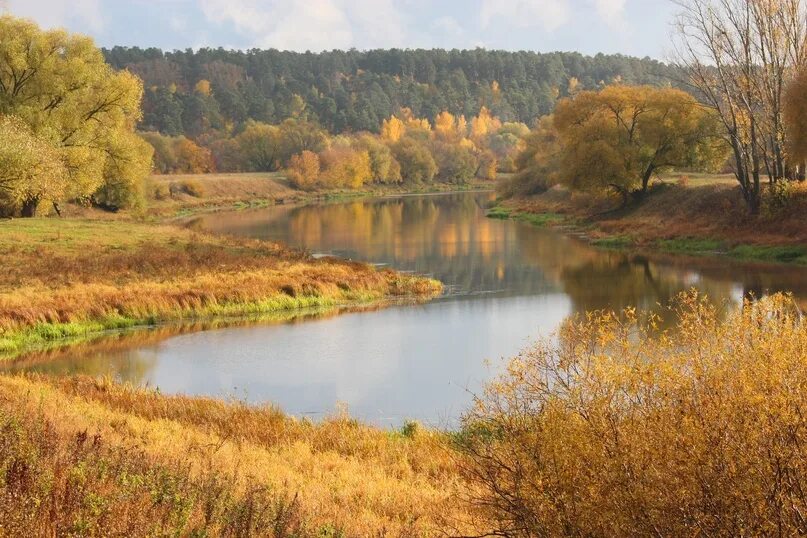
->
[[0, 218, 442, 356]]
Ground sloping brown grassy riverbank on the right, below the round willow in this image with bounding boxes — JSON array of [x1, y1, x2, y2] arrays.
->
[[496, 176, 807, 264]]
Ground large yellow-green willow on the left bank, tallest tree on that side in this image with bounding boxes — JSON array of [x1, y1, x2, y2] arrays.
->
[[0, 16, 151, 215]]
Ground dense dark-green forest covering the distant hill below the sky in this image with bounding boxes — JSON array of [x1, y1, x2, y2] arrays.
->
[[103, 47, 677, 137]]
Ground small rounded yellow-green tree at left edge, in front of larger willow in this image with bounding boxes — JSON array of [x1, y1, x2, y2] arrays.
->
[[0, 116, 69, 217]]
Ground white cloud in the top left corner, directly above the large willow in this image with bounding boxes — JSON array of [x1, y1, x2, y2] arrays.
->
[[7, 0, 104, 32]]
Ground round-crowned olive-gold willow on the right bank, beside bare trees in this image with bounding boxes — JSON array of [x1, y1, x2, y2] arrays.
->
[[553, 85, 725, 202]]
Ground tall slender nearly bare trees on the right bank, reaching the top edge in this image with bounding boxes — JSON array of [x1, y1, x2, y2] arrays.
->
[[675, 0, 807, 213]]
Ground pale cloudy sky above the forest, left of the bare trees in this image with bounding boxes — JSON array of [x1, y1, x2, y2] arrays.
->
[[0, 0, 675, 59]]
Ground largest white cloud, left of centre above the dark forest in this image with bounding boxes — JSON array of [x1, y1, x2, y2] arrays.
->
[[201, 0, 404, 51]]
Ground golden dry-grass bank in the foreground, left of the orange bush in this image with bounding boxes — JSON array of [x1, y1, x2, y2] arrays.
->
[[0, 370, 468, 537]]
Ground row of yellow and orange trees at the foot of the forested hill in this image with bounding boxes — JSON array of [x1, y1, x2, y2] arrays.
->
[[142, 107, 529, 190]]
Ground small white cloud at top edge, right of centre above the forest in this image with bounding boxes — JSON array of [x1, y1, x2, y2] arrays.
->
[[479, 0, 571, 32]]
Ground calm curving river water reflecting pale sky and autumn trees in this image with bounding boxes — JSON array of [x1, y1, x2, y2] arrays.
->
[[16, 193, 807, 426]]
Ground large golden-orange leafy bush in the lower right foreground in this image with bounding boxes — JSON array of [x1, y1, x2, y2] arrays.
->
[[456, 292, 807, 536]]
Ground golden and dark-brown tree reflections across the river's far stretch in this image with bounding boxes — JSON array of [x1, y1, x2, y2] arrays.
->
[[194, 193, 807, 310]]
